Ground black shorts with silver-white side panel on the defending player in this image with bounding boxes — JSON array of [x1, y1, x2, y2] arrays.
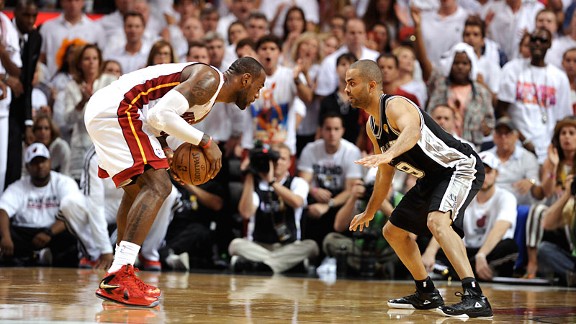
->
[[390, 158, 484, 237]]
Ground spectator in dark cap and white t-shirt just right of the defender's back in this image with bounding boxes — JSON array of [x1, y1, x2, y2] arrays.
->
[[489, 117, 544, 205]]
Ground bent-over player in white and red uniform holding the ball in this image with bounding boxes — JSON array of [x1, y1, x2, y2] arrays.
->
[[84, 57, 266, 307]]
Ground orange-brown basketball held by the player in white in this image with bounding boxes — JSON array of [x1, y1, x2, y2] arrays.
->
[[171, 143, 210, 186]]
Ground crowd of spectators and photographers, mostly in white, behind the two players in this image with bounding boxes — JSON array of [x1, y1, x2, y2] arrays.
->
[[0, 0, 576, 285]]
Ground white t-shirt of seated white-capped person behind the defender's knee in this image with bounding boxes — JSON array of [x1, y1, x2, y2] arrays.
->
[[464, 186, 518, 248]]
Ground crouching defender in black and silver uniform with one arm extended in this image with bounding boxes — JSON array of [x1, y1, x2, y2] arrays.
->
[[345, 60, 492, 318]]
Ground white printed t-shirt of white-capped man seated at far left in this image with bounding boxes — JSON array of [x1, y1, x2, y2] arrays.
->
[[0, 171, 80, 228]]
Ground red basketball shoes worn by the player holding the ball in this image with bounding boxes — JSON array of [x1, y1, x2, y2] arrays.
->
[[96, 264, 160, 307]]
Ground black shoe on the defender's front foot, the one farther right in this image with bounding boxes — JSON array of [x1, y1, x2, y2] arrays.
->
[[437, 289, 492, 319]]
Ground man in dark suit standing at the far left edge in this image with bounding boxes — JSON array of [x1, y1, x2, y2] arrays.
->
[[5, 0, 42, 187]]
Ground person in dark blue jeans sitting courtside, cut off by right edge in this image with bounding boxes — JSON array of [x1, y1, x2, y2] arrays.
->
[[538, 174, 576, 286]]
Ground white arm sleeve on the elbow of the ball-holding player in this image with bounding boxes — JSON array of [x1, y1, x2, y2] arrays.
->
[[148, 89, 204, 145]]
